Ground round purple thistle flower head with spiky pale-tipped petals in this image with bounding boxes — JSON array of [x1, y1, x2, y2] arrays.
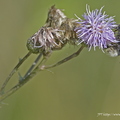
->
[[75, 5, 118, 50]]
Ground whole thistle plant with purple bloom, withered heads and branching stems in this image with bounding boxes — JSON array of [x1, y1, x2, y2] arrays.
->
[[0, 5, 120, 101]]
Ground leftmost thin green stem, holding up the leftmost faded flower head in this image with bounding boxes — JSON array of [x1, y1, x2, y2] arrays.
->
[[0, 52, 31, 94]]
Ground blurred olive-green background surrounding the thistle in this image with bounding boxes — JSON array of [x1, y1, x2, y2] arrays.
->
[[0, 0, 120, 120]]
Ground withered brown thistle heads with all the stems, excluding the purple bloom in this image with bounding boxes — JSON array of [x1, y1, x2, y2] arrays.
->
[[0, 6, 85, 101]]
